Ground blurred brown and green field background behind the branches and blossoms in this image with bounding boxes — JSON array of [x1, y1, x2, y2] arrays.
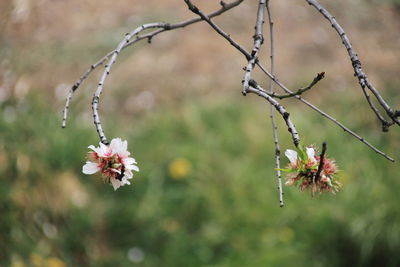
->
[[0, 0, 400, 267]]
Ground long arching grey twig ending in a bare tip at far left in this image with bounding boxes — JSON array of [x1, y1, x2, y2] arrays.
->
[[61, 0, 244, 128]]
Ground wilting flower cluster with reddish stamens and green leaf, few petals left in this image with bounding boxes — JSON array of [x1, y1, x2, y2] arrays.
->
[[283, 147, 341, 195]]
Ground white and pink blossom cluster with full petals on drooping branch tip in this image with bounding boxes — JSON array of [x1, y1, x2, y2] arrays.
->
[[82, 138, 139, 190]]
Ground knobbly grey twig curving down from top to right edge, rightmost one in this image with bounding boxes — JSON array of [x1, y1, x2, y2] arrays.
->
[[306, 0, 400, 131]]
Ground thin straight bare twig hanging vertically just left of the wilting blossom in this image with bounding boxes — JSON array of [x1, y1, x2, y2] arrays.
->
[[266, 0, 284, 207]]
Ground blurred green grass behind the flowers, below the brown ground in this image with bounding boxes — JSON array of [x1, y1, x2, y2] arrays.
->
[[0, 90, 400, 266]]
